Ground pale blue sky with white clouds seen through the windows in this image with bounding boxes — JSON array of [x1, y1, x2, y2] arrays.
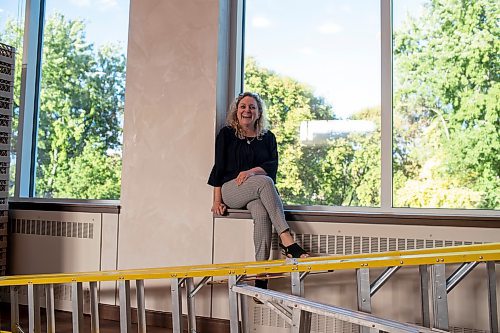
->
[[0, 0, 426, 118]]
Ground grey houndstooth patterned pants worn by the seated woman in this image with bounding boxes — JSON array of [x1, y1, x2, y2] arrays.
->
[[222, 175, 290, 261]]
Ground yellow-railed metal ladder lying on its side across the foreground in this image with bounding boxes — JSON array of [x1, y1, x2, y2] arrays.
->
[[0, 243, 500, 333]]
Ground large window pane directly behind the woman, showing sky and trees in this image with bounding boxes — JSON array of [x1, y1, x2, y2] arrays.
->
[[244, 0, 380, 206]]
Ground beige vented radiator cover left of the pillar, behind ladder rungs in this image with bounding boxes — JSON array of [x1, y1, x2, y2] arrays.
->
[[7, 210, 118, 313]]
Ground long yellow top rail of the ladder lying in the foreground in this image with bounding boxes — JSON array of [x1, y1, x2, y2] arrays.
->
[[0, 243, 500, 286]]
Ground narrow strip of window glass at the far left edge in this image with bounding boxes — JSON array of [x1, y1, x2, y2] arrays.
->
[[0, 0, 26, 196]]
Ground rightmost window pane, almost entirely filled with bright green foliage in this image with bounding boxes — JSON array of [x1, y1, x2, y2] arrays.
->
[[393, 0, 500, 209]]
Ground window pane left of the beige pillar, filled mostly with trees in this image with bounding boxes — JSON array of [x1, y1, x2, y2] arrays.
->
[[36, 0, 129, 199]]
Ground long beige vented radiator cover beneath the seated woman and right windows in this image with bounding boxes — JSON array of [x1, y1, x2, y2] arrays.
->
[[212, 219, 500, 333]]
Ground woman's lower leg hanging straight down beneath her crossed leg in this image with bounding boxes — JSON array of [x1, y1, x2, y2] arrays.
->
[[247, 199, 273, 261]]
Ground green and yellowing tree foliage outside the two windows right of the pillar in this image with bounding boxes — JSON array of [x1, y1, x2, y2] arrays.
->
[[245, 0, 500, 208]]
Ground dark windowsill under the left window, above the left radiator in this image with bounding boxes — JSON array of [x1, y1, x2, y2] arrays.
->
[[9, 198, 121, 214]]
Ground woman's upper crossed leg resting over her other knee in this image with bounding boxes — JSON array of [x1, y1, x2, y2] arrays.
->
[[222, 175, 290, 235]]
